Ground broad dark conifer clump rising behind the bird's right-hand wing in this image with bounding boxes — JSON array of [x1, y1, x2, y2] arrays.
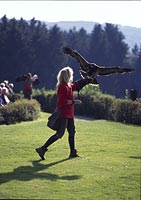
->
[[89, 24, 128, 97]]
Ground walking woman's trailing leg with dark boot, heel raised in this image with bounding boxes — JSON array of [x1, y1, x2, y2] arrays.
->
[[36, 118, 68, 160]]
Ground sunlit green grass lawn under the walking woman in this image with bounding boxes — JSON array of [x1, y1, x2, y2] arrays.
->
[[0, 113, 141, 200]]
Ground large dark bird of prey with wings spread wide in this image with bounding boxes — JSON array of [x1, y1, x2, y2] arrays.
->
[[63, 47, 134, 84]]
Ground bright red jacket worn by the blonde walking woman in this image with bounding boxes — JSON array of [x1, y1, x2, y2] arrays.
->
[[57, 83, 78, 118]]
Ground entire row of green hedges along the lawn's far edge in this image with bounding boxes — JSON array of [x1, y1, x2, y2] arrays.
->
[[0, 87, 141, 125]]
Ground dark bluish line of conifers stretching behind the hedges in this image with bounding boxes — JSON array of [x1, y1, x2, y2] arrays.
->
[[0, 15, 141, 98]]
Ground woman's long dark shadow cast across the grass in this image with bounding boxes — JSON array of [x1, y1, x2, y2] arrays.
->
[[0, 158, 81, 184]]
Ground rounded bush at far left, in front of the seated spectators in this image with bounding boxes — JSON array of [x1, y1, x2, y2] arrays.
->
[[0, 99, 40, 124]]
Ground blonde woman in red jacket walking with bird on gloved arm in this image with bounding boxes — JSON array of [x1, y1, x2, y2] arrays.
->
[[36, 67, 92, 160]]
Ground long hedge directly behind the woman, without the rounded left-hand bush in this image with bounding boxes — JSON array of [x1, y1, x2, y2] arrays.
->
[[34, 86, 141, 125]]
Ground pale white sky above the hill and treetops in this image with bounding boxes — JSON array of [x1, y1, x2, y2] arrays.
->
[[0, 0, 141, 28]]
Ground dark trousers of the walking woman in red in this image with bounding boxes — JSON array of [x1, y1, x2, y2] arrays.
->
[[42, 118, 76, 151]]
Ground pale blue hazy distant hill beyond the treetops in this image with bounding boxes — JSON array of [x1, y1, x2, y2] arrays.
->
[[45, 21, 141, 49]]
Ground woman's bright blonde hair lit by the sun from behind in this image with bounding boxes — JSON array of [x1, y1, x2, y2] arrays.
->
[[56, 66, 73, 88]]
